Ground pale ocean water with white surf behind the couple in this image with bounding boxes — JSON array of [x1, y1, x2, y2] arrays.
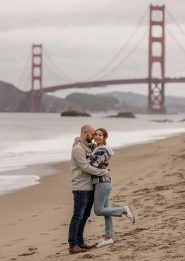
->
[[0, 113, 185, 195]]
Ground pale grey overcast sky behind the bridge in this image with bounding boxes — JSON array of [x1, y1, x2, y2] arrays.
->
[[0, 0, 185, 96]]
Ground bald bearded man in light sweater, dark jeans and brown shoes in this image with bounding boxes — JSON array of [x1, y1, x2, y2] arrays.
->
[[68, 125, 109, 254]]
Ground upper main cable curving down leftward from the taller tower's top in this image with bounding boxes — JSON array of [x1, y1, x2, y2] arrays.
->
[[88, 8, 148, 80]]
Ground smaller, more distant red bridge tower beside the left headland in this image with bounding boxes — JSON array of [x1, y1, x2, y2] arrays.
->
[[30, 44, 43, 112]]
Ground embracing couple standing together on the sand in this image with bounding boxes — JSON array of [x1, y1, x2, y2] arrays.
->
[[68, 125, 135, 254]]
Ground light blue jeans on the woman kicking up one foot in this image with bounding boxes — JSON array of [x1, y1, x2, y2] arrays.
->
[[94, 182, 123, 237]]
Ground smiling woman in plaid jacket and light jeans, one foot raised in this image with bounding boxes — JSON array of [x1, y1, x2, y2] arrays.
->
[[76, 128, 135, 247]]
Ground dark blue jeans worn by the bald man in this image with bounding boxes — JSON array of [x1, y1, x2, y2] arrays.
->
[[68, 190, 94, 247]]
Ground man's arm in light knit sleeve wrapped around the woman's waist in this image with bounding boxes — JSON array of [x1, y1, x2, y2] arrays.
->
[[73, 145, 109, 176]]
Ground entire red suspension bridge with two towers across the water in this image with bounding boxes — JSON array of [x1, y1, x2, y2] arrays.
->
[[18, 5, 185, 113]]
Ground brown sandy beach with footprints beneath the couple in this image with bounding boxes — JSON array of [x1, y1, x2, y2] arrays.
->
[[0, 135, 185, 261]]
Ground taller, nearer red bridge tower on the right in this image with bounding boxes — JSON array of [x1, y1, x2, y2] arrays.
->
[[148, 5, 166, 113]]
